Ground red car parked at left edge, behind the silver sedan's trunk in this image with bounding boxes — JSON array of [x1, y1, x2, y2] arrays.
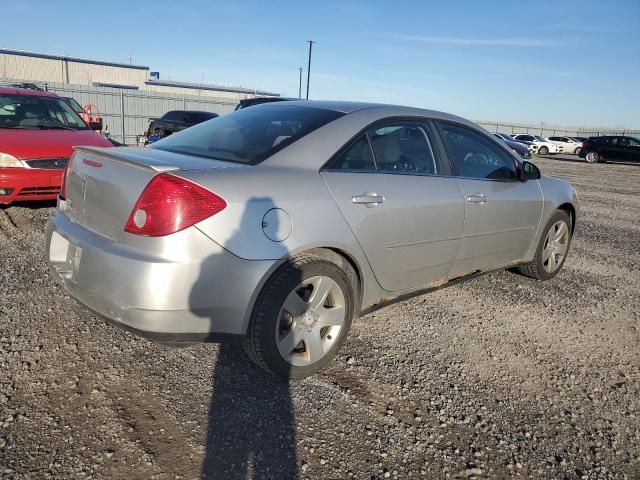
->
[[0, 87, 113, 204]]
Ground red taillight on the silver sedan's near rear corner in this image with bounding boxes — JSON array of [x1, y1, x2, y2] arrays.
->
[[124, 173, 227, 237]]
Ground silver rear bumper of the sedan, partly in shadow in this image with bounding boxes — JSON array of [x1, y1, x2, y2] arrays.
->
[[46, 212, 275, 342]]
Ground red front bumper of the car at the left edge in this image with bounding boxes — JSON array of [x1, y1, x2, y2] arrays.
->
[[0, 168, 62, 204]]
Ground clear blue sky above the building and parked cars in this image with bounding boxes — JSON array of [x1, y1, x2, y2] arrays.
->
[[5, 0, 640, 128]]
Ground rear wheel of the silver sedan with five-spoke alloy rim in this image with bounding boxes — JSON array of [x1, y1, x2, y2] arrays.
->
[[243, 249, 359, 380]]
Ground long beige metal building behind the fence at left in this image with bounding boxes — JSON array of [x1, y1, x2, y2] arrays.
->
[[0, 48, 279, 100]]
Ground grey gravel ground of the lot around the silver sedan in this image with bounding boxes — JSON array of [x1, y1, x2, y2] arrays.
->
[[0, 157, 640, 479]]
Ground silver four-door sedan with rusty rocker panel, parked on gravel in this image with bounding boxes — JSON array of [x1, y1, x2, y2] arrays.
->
[[47, 101, 578, 378]]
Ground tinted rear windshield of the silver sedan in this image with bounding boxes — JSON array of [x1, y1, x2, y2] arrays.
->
[[151, 102, 344, 165]]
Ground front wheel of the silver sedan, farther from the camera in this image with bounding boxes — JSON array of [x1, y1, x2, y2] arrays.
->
[[517, 210, 573, 280]]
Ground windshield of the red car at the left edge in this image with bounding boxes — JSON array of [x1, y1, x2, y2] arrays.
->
[[0, 95, 88, 130]]
